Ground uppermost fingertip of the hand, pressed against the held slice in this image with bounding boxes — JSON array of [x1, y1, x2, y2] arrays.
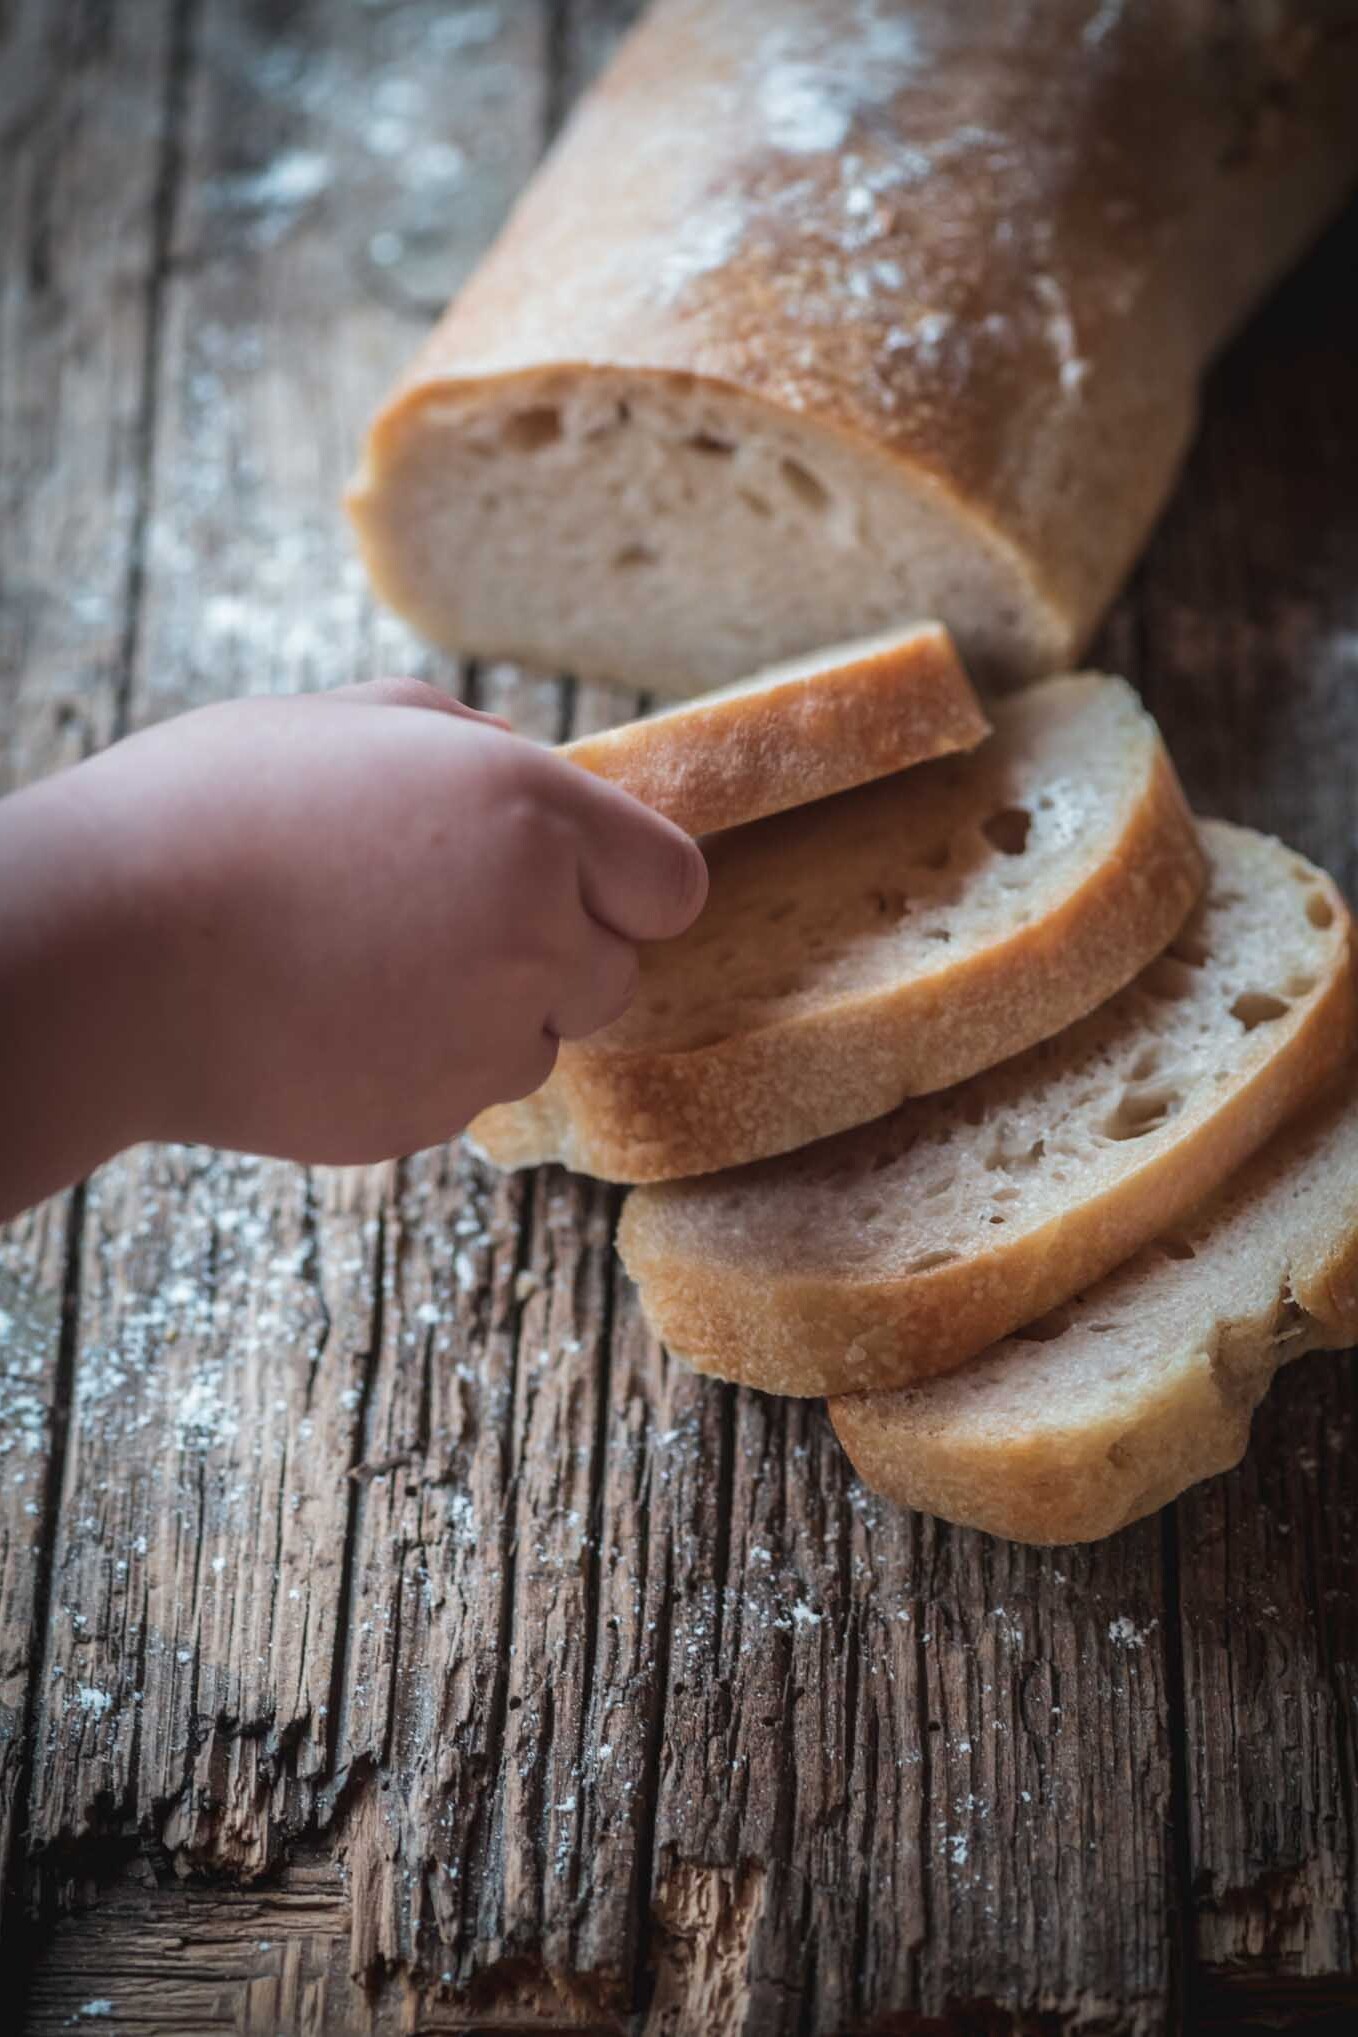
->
[[562, 764, 706, 941]]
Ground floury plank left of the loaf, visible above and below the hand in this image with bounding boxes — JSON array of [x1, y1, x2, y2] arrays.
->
[[14, 4, 542, 1971]]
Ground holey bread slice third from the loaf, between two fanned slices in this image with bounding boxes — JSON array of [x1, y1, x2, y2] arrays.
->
[[619, 823, 1354, 1393]]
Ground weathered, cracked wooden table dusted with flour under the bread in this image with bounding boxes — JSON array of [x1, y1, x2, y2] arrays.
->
[[0, 0, 1358, 2037]]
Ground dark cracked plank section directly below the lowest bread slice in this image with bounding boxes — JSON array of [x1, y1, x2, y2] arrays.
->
[[627, 1379, 1171, 2031]]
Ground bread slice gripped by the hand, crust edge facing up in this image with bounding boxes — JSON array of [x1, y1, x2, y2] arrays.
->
[[562, 623, 989, 835]]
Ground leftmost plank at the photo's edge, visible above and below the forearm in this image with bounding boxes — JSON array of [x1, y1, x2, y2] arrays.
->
[[0, 0, 177, 1921]]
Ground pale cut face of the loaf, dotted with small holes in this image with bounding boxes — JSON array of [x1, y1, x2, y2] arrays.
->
[[348, 369, 1075, 697]]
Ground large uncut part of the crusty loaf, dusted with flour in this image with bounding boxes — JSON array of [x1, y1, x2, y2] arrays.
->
[[350, 0, 1358, 695]]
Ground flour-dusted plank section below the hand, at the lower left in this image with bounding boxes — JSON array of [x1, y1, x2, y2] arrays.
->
[[31, 1149, 379, 1901]]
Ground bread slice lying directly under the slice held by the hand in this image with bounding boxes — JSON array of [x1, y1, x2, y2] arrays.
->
[[470, 676, 1203, 1181]]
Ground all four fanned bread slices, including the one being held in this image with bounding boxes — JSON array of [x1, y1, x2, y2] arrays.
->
[[470, 625, 1358, 1542]]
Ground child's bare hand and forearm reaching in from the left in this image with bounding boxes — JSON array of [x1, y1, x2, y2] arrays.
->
[[0, 680, 706, 1218]]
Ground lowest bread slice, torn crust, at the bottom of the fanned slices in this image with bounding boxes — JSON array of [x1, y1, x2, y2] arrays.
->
[[831, 1069, 1358, 1542]]
